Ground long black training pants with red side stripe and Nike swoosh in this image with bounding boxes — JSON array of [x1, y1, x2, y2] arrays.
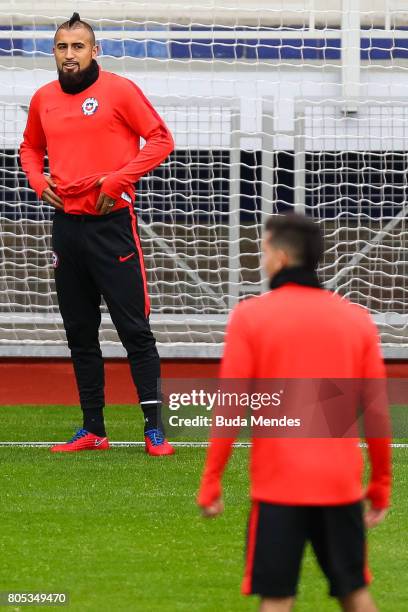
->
[[52, 208, 160, 410]]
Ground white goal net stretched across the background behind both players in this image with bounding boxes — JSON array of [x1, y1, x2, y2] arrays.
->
[[0, 0, 408, 358]]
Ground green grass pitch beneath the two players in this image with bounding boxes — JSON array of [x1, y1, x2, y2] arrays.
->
[[0, 406, 408, 612]]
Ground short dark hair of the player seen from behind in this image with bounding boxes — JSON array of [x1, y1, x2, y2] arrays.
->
[[265, 213, 324, 270]]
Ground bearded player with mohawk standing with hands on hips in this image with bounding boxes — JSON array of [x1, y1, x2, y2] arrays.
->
[[20, 13, 174, 455]]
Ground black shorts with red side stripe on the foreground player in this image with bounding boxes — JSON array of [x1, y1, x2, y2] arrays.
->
[[242, 502, 370, 597]]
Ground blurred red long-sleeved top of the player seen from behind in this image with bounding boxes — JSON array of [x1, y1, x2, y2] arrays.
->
[[198, 283, 391, 508]]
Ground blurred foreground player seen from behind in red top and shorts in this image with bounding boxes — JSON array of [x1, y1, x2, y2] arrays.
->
[[198, 215, 391, 612]]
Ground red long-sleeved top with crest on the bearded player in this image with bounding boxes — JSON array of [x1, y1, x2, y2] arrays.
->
[[20, 69, 174, 214]]
